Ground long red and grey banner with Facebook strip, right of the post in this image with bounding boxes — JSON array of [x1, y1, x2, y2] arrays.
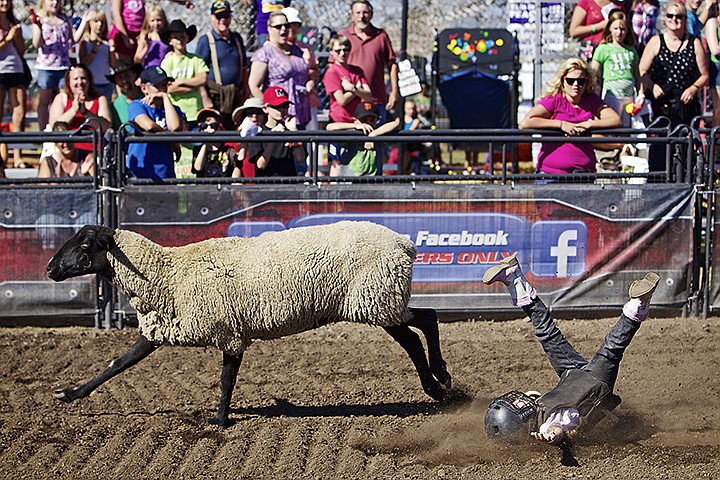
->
[[121, 184, 694, 311]]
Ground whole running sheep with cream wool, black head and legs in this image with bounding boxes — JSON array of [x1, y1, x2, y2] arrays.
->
[[47, 222, 451, 426]]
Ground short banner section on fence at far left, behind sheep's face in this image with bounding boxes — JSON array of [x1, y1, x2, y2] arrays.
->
[[0, 186, 98, 317]]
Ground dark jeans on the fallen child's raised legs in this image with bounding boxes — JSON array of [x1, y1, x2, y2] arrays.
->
[[522, 298, 640, 391]]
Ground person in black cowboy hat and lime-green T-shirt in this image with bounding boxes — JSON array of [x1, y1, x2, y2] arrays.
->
[[160, 20, 212, 128]]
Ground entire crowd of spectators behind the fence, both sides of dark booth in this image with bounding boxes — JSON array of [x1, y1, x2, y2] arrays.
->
[[0, 0, 720, 179]]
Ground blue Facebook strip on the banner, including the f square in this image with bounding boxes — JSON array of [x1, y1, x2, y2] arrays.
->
[[228, 212, 588, 282]]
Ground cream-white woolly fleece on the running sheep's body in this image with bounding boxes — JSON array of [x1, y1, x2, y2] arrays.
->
[[108, 222, 416, 354]]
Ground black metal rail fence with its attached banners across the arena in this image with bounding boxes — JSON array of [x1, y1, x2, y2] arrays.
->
[[0, 120, 720, 327]]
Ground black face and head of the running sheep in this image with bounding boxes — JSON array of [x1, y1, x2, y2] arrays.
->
[[47, 225, 114, 282]]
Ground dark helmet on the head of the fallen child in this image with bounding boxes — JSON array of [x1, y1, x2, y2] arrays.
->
[[485, 390, 537, 443]]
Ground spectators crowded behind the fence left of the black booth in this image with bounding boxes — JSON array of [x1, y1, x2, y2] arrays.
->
[[0, 0, 428, 179]]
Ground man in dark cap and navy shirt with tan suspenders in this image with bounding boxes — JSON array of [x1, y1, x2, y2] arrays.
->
[[195, 0, 247, 129]]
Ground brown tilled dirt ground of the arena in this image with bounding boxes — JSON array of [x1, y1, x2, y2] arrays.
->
[[0, 318, 720, 480]]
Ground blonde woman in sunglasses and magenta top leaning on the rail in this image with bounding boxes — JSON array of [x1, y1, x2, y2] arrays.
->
[[520, 58, 621, 174]]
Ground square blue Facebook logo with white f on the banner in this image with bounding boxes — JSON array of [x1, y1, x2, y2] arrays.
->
[[530, 221, 587, 278]]
